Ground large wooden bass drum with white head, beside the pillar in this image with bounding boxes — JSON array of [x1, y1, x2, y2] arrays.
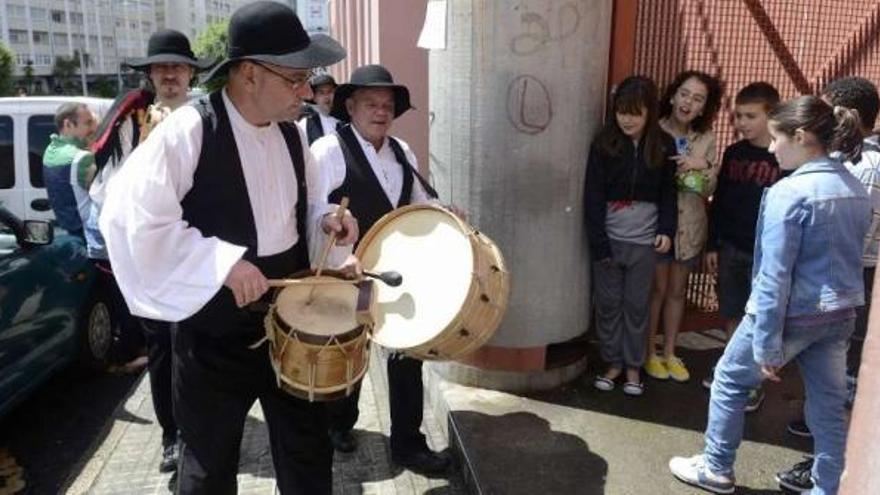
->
[[356, 205, 510, 360]]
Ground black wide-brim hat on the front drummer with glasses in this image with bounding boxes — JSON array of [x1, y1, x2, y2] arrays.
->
[[205, 1, 346, 80]]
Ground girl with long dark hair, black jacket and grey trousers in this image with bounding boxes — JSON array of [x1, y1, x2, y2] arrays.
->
[[584, 76, 676, 395]]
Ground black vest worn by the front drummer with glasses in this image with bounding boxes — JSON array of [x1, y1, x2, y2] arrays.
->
[[181, 91, 309, 333]]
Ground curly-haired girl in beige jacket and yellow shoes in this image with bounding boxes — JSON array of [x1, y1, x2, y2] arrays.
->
[[645, 71, 721, 382]]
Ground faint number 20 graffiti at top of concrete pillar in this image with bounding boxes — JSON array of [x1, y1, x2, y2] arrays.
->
[[510, 2, 581, 56]]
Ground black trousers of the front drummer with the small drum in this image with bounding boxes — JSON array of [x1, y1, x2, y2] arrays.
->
[[173, 319, 333, 495]]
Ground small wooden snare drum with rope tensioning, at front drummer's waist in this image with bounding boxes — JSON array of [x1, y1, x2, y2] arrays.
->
[[265, 270, 374, 401]]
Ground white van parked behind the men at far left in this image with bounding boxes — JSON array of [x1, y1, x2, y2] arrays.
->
[[0, 96, 113, 220]]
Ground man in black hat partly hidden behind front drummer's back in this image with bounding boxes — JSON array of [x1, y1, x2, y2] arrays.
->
[[86, 29, 211, 472]]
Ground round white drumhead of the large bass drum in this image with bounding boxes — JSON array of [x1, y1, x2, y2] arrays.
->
[[356, 205, 474, 350]]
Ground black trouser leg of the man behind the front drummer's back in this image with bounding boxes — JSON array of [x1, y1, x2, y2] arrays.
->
[[140, 318, 177, 447]]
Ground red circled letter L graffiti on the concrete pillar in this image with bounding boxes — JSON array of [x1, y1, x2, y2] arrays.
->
[[507, 75, 553, 134]]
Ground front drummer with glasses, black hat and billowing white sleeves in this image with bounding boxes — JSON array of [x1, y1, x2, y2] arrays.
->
[[101, 1, 358, 495]]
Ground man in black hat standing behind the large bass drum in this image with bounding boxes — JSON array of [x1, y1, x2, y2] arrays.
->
[[312, 65, 449, 474]]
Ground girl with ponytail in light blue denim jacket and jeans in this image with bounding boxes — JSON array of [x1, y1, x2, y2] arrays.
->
[[669, 96, 871, 494]]
